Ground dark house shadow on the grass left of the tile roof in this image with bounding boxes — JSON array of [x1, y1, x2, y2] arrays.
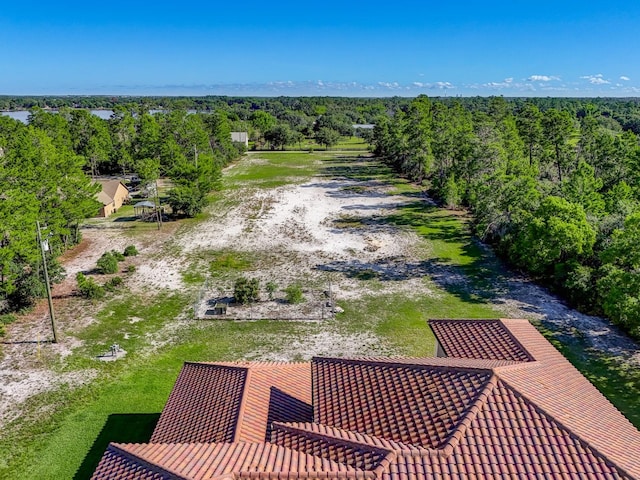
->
[[73, 413, 160, 480]]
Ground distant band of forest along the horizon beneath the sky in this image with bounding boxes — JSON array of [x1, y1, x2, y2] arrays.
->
[[0, 95, 640, 134]]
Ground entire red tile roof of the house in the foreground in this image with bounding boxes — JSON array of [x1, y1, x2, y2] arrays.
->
[[94, 320, 640, 480]]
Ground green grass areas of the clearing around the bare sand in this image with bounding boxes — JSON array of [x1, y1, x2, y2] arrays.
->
[[0, 152, 640, 480]]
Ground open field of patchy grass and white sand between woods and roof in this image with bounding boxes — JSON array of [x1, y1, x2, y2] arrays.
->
[[0, 151, 640, 479]]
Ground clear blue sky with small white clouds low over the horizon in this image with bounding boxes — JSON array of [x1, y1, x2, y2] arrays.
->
[[0, 0, 640, 96]]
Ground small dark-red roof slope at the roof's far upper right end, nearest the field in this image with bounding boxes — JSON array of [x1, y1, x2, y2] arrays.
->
[[429, 320, 533, 362]]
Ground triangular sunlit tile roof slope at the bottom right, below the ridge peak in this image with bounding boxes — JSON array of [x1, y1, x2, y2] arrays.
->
[[408, 381, 630, 480]]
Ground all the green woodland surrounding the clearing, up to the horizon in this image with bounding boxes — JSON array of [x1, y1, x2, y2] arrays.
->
[[0, 96, 640, 336]]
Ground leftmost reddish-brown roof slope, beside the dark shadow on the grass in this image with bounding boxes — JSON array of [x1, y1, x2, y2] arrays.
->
[[151, 363, 248, 443]]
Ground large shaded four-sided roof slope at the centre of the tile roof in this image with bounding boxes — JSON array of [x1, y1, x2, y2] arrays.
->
[[312, 358, 492, 448]]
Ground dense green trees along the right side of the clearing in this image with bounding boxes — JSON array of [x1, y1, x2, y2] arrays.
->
[[374, 96, 640, 336]]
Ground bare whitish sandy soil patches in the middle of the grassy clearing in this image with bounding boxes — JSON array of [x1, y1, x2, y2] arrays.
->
[[0, 157, 640, 425]]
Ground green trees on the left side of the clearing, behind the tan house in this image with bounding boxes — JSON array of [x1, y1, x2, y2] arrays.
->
[[0, 104, 242, 313]]
